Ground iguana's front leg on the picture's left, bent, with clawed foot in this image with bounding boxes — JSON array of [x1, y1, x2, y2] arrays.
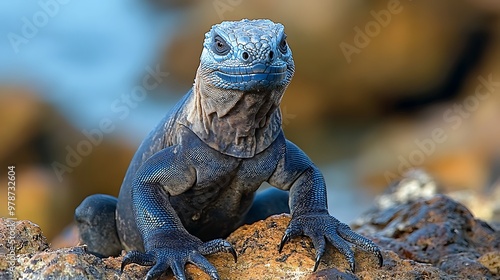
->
[[122, 146, 236, 279]]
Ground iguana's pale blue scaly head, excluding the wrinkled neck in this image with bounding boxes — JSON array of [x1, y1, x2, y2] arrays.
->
[[199, 19, 295, 91]]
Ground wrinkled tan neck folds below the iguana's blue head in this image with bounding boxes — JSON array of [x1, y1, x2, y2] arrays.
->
[[180, 69, 282, 158]]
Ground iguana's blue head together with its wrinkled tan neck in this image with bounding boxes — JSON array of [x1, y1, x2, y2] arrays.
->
[[185, 19, 295, 158]]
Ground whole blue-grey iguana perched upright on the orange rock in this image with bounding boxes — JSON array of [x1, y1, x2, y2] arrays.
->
[[75, 20, 382, 279]]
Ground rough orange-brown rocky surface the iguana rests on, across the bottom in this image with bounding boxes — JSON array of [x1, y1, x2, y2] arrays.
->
[[0, 192, 500, 279]]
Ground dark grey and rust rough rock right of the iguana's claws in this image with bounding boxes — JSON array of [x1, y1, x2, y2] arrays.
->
[[354, 195, 500, 279]]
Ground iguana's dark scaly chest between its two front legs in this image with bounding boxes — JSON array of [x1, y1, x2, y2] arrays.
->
[[170, 128, 284, 239]]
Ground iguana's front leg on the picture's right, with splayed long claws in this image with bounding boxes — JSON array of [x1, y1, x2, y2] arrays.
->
[[270, 141, 383, 272]]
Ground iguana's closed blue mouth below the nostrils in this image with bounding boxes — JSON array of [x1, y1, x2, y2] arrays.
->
[[215, 63, 287, 83]]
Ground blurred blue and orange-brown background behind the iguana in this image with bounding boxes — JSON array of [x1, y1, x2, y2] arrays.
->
[[0, 0, 500, 247]]
